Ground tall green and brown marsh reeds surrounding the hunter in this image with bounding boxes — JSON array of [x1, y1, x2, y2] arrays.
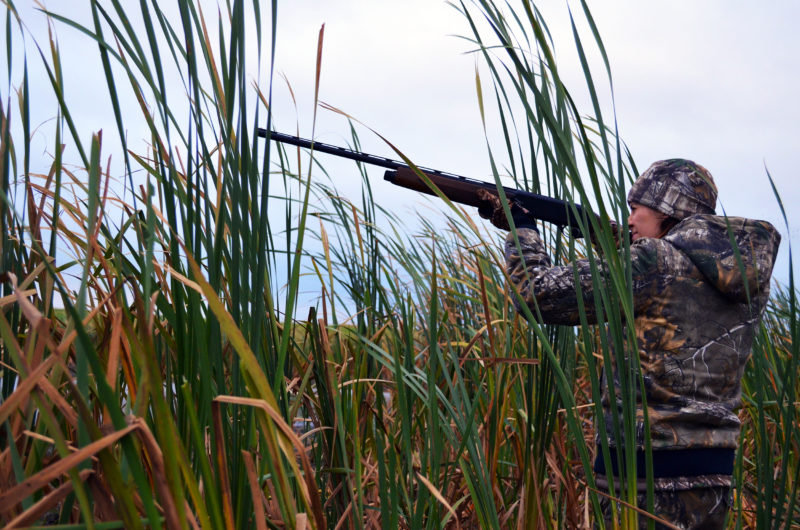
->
[[0, 0, 800, 529]]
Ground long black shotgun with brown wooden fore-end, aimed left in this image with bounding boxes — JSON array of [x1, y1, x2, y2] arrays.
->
[[258, 129, 594, 237]]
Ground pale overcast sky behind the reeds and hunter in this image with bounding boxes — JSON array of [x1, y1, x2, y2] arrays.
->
[[4, 0, 800, 282]]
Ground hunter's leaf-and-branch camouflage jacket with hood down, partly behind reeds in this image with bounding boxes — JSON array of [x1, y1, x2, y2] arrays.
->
[[505, 215, 780, 449]]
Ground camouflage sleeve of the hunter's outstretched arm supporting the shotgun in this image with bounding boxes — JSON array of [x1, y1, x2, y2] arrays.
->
[[505, 228, 657, 326]]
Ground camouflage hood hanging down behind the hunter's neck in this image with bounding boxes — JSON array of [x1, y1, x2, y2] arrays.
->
[[664, 215, 781, 304]]
